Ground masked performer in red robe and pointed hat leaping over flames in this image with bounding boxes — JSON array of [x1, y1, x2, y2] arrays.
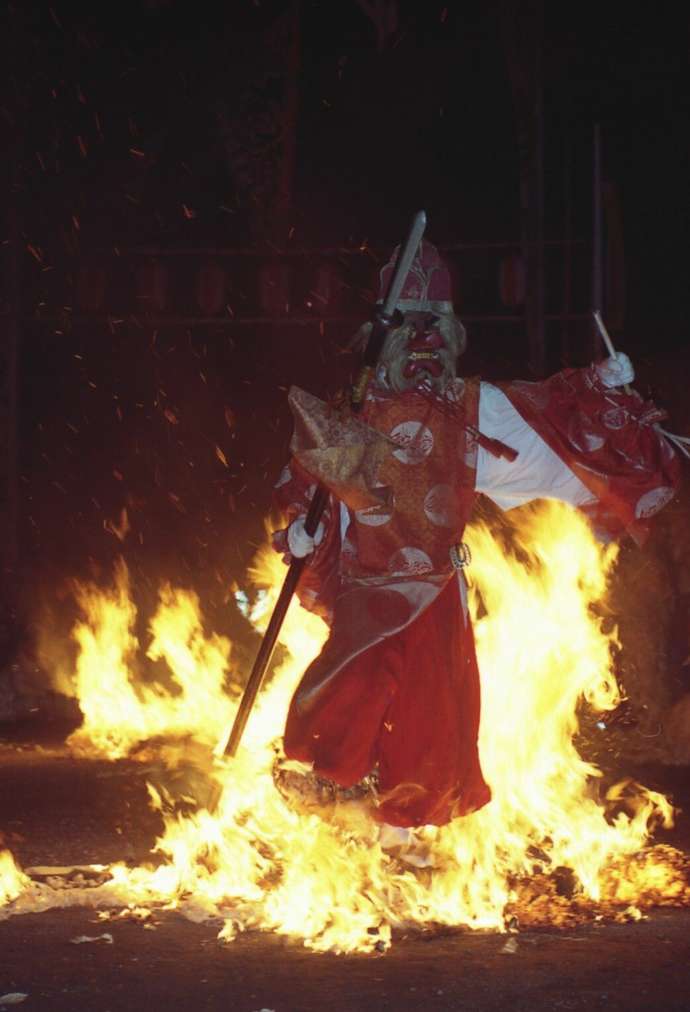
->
[[274, 241, 679, 827]]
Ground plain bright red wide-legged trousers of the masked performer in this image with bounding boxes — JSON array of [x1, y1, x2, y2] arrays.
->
[[284, 578, 491, 826]]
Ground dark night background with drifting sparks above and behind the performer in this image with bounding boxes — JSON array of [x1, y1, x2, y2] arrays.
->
[[0, 0, 689, 680]]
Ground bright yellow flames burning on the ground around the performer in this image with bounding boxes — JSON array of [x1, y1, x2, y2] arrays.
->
[[0, 503, 690, 952]]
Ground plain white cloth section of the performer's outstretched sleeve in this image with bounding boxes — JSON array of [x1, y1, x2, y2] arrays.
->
[[477, 383, 596, 510]]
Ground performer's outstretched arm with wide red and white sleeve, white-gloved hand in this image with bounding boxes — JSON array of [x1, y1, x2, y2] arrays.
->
[[478, 352, 680, 541]]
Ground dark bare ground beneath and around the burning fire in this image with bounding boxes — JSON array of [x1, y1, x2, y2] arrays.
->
[[0, 726, 690, 1012]]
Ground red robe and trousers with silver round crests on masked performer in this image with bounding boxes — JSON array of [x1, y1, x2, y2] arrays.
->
[[276, 372, 677, 826]]
